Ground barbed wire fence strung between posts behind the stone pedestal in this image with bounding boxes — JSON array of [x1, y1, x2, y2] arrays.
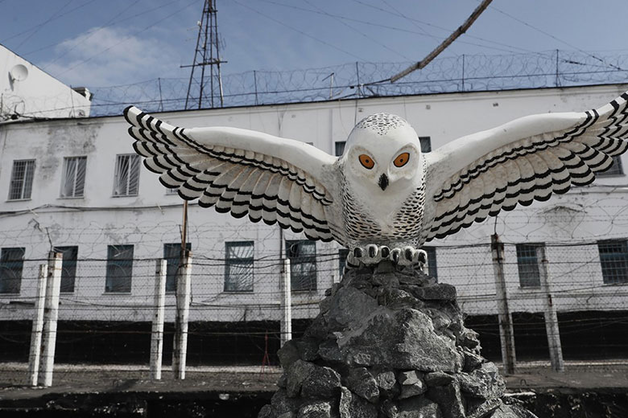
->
[[0, 237, 628, 385]]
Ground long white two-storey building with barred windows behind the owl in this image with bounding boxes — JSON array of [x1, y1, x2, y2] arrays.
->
[[0, 85, 628, 328]]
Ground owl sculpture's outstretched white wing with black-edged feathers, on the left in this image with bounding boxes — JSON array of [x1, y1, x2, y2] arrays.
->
[[124, 106, 337, 241]]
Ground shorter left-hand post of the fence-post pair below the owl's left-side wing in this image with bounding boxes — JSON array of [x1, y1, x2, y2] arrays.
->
[[150, 260, 168, 380]]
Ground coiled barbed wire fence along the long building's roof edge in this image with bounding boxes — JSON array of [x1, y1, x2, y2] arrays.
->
[[87, 50, 628, 116]]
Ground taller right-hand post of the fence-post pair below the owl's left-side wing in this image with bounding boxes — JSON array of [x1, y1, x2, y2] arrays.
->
[[172, 250, 192, 380]]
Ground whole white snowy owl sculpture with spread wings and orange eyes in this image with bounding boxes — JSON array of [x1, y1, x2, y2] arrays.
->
[[124, 93, 628, 265]]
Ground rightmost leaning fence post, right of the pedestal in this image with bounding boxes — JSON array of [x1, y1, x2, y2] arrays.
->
[[536, 246, 565, 372]]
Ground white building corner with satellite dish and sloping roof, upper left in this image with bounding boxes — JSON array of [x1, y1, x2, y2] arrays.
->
[[0, 45, 91, 122]]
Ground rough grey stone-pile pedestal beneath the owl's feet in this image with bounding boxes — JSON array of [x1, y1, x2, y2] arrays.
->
[[259, 262, 534, 418]]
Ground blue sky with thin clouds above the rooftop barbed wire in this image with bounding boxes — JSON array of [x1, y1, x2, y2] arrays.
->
[[0, 0, 628, 88]]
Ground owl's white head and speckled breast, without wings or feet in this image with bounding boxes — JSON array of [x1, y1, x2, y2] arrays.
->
[[339, 113, 425, 247]]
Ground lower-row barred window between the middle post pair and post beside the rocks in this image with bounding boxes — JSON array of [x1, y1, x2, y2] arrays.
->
[[225, 241, 254, 292]]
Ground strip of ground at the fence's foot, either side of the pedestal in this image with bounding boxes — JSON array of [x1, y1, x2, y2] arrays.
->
[[0, 360, 628, 418]]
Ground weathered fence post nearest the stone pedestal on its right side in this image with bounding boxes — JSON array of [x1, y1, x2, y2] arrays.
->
[[491, 234, 517, 374]]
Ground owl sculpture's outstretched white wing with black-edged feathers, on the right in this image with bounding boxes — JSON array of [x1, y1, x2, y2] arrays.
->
[[421, 93, 628, 241]]
